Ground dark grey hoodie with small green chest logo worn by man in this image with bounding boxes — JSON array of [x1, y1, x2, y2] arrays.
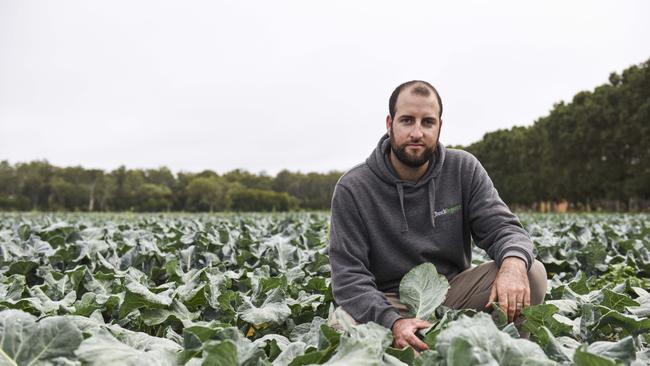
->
[[329, 135, 534, 328]]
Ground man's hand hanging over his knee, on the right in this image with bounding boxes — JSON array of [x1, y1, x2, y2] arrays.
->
[[485, 257, 530, 322]]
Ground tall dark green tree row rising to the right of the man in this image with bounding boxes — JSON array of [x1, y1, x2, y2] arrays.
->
[[465, 60, 650, 211]]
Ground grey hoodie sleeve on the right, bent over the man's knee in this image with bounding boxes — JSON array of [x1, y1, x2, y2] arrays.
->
[[468, 159, 535, 269]]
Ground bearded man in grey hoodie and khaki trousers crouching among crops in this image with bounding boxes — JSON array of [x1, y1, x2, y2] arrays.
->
[[329, 80, 546, 350]]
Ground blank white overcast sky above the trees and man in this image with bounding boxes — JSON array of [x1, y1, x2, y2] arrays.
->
[[0, 0, 650, 174]]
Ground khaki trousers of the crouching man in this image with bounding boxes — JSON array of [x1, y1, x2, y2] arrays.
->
[[330, 260, 547, 328]]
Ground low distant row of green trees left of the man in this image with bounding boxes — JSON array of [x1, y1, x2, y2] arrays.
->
[[0, 161, 341, 212]]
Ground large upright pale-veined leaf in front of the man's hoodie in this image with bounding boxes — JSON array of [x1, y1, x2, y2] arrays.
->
[[399, 263, 449, 320]]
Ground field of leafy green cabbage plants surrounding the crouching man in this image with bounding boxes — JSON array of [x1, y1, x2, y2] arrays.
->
[[0, 213, 650, 366]]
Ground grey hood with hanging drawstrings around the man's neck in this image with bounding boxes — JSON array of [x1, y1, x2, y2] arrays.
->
[[366, 134, 446, 232]]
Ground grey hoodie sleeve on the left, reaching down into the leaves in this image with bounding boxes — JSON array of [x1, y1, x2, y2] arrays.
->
[[329, 183, 401, 329]]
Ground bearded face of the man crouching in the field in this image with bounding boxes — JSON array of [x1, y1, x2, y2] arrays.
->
[[386, 87, 442, 168]]
